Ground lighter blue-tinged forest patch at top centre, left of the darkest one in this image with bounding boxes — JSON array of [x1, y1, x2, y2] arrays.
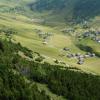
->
[[29, 0, 65, 11]]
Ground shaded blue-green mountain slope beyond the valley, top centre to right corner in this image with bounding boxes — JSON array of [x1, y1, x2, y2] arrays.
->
[[30, 0, 100, 20]]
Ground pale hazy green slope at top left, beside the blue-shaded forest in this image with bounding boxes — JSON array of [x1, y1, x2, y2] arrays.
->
[[0, 0, 33, 15]]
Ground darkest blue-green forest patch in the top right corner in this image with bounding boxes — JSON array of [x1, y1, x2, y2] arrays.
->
[[74, 0, 100, 19]]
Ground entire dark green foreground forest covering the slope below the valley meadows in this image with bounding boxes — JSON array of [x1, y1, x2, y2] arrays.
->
[[0, 36, 100, 100]]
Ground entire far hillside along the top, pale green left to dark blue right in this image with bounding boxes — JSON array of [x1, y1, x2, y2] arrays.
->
[[0, 0, 100, 21]]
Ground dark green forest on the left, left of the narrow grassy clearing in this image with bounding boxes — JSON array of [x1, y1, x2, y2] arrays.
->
[[0, 40, 50, 100]]
